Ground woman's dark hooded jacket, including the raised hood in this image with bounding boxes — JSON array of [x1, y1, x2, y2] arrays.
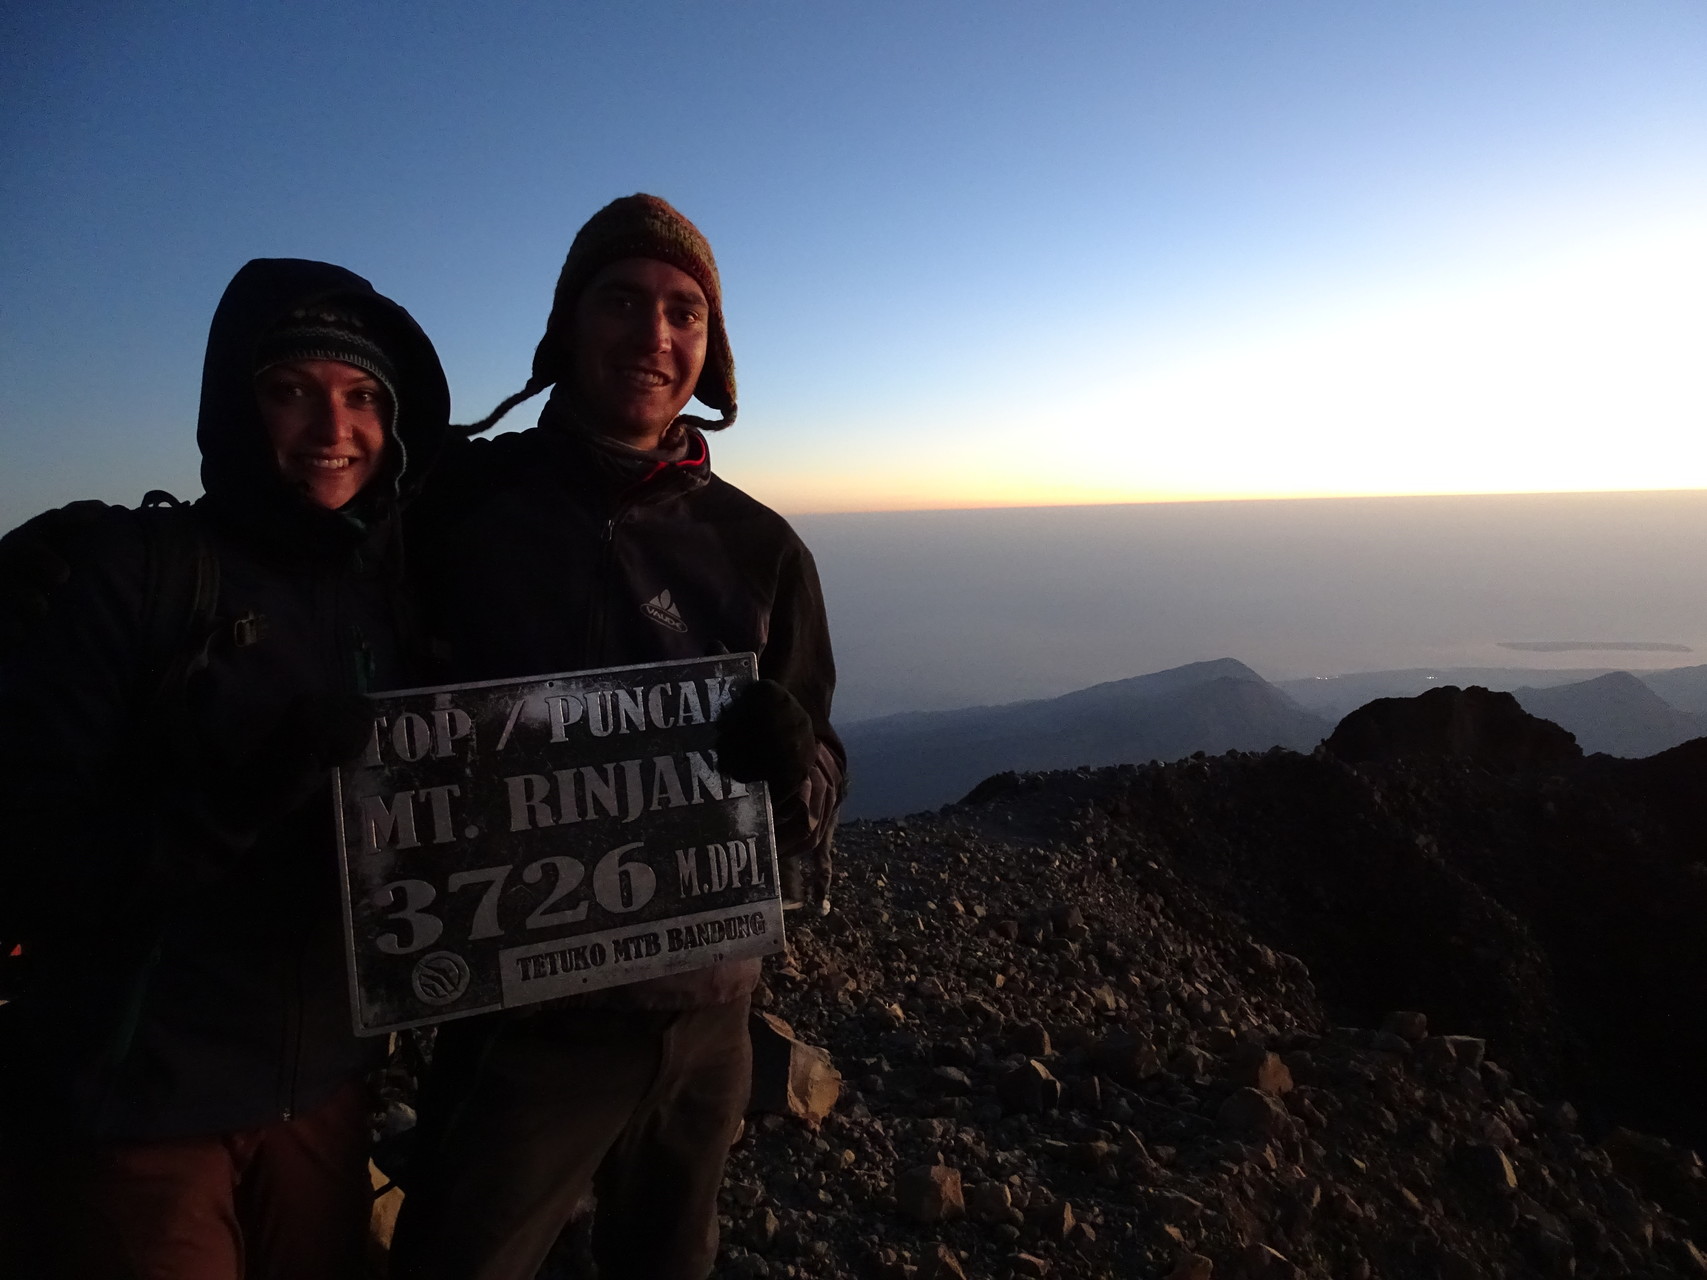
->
[[0, 259, 449, 1138]]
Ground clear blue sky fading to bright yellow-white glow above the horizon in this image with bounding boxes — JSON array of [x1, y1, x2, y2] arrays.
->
[[0, 0, 1707, 524]]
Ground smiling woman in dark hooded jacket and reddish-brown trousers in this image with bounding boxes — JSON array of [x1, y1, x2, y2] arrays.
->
[[0, 259, 449, 1280]]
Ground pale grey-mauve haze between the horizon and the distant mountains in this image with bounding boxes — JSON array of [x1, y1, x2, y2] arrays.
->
[[795, 492, 1707, 720]]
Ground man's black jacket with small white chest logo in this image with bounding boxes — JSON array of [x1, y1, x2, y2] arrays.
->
[[408, 401, 845, 1009]]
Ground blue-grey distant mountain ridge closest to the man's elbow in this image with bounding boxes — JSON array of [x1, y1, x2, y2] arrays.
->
[[842, 657, 1331, 817]]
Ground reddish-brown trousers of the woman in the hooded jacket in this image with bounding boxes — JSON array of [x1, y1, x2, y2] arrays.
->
[[0, 1084, 374, 1280]]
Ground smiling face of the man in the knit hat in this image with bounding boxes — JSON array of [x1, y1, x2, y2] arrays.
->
[[570, 258, 710, 449]]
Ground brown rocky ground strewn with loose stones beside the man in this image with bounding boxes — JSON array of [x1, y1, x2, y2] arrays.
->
[[693, 753, 1707, 1280]]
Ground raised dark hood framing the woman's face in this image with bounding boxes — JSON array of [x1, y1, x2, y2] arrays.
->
[[196, 258, 451, 555]]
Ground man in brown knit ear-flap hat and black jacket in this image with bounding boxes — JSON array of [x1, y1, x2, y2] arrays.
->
[[393, 195, 843, 1280]]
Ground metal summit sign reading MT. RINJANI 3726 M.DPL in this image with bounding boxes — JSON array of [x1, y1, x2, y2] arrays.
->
[[336, 654, 782, 1034]]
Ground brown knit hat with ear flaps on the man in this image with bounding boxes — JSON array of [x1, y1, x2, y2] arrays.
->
[[461, 195, 736, 435]]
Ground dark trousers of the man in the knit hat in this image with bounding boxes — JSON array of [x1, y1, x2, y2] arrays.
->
[[391, 998, 753, 1280]]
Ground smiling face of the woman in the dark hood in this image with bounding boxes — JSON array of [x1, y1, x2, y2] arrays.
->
[[254, 360, 391, 510]]
